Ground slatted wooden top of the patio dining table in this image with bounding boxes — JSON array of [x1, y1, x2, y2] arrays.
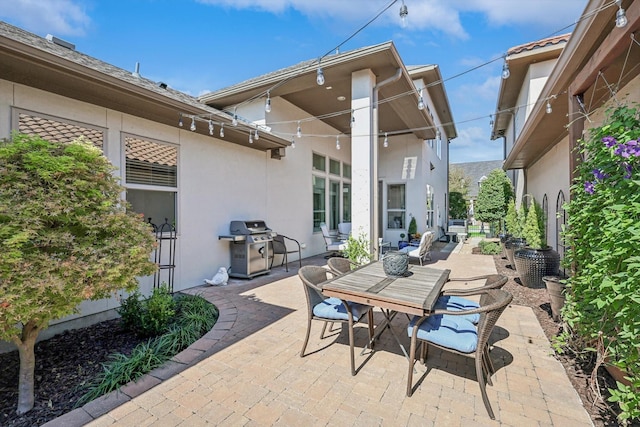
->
[[322, 261, 451, 316]]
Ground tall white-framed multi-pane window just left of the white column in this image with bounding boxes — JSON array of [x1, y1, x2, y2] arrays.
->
[[312, 153, 351, 231]]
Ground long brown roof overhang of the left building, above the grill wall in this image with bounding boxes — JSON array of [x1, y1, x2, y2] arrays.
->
[[0, 24, 289, 151]]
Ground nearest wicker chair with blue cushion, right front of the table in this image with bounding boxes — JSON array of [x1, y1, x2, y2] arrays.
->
[[407, 289, 513, 419]]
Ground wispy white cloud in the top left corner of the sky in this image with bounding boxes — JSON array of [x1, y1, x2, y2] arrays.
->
[[0, 0, 91, 36]]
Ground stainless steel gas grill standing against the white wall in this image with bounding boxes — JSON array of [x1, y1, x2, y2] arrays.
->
[[218, 220, 273, 279]]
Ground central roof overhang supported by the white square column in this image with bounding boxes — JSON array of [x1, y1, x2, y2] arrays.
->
[[200, 42, 444, 139]]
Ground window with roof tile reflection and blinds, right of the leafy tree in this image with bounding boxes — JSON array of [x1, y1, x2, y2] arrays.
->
[[124, 135, 178, 228]]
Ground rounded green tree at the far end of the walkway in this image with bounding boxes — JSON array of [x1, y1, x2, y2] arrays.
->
[[475, 169, 513, 232]]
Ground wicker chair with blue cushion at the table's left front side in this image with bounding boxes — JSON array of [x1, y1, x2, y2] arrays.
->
[[298, 265, 373, 375]]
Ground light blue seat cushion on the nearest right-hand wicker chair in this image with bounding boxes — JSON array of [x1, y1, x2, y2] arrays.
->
[[407, 314, 478, 353]]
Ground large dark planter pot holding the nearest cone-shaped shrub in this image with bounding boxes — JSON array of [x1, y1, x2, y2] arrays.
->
[[513, 247, 560, 288]]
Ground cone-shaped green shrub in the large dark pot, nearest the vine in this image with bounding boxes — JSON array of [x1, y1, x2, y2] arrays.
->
[[513, 198, 560, 288]]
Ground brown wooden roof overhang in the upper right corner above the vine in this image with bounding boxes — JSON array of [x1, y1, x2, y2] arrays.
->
[[504, 0, 640, 169]]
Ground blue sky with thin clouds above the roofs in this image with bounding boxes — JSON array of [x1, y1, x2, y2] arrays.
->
[[0, 0, 587, 163]]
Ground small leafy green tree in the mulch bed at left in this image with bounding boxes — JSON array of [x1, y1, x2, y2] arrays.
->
[[0, 133, 156, 414]]
